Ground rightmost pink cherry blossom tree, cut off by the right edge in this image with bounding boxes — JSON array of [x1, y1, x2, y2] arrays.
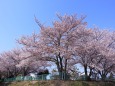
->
[[92, 31, 115, 80]]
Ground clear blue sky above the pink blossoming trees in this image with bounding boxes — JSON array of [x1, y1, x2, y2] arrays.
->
[[0, 0, 115, 52]]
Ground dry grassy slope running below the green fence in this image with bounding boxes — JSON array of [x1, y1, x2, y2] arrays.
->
[[0, 80, 115, 86]]
